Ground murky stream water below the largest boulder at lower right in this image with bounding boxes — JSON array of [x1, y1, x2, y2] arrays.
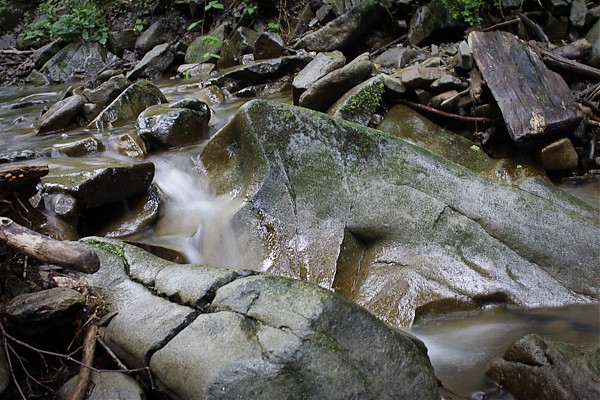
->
[[408, 305, 600, 399]]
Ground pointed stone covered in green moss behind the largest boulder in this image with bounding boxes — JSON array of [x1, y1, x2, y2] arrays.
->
[[327, 75, 385, 126]]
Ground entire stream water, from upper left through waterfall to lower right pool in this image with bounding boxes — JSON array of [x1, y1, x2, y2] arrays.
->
[[0, 80, 600, 399]]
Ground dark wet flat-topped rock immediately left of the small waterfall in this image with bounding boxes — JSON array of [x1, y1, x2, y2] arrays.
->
[[42, 158, 154, 209]]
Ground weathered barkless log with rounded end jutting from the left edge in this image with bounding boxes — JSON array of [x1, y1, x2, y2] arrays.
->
[[0, 217, 100, 274]]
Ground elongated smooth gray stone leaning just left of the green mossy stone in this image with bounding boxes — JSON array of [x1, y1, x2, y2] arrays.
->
[[298, 53, 374, 111]]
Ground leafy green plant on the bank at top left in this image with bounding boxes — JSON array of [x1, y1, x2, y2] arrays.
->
[[21, 0, 109, 45]]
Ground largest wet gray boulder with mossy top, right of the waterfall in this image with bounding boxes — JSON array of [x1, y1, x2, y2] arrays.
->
[[201, 101, 600, 326]]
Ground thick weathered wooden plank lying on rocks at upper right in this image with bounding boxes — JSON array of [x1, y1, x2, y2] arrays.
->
[[468, 31, 581, 148]]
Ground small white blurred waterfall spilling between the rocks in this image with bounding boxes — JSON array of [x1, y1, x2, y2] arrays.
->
[[154, 157, 241, 267]]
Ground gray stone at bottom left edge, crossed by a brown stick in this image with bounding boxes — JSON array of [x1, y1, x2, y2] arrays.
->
[[57, 371, 146, 400]]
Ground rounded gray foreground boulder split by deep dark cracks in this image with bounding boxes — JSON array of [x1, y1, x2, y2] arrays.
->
[[85, 238, 439, 400]]
